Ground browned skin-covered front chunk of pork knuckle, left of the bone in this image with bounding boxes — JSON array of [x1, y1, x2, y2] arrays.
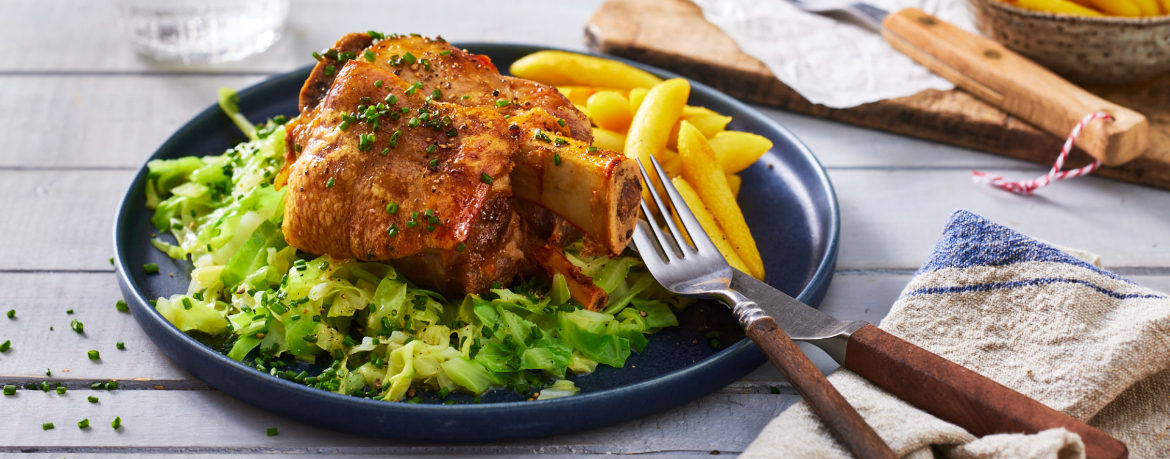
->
[[283, 61, 523, 292]]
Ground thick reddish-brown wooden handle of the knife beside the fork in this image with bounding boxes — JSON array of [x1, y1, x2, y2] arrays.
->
[[845, 326, 1129, 459]]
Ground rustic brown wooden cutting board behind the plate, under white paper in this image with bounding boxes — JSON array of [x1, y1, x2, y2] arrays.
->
[[585, 0, 1170, 190]]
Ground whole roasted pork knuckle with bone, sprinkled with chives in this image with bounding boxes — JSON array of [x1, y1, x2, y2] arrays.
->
[[284, 34, 641, 293]]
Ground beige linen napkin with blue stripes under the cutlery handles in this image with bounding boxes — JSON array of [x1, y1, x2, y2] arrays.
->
[[742, 211, 1170, 459]]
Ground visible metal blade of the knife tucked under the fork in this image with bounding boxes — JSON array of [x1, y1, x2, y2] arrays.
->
[[731, 268, 868, 363]]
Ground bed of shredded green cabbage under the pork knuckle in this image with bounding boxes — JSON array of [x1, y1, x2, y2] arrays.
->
[[146, 89, 683, 403]]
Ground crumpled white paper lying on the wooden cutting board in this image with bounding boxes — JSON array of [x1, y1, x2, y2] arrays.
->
[[691, 0, 977, 108]]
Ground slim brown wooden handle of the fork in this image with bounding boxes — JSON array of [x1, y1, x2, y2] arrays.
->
[[746, 317, 897, 459]]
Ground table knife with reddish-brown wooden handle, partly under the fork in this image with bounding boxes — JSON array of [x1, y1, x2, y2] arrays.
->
[[731, 269, 1129, 459]]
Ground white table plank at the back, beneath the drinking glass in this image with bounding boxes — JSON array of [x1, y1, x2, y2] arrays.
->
[[0, 0, 600, 75]]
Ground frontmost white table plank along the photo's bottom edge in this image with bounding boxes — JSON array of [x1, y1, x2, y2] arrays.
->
[[0, 390, 799, 454]]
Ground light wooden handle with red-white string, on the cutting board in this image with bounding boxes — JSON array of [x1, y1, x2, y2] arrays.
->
[[882, 8, 1149, 165]]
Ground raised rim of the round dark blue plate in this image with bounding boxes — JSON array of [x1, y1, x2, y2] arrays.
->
[[113, 42, 840, 441]]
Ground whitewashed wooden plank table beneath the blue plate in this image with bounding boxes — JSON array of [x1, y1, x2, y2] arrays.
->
[[0, 0, 1170, 458]]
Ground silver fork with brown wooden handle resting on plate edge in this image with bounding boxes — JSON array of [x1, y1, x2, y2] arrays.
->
[[633, 157, 895, 458]]
